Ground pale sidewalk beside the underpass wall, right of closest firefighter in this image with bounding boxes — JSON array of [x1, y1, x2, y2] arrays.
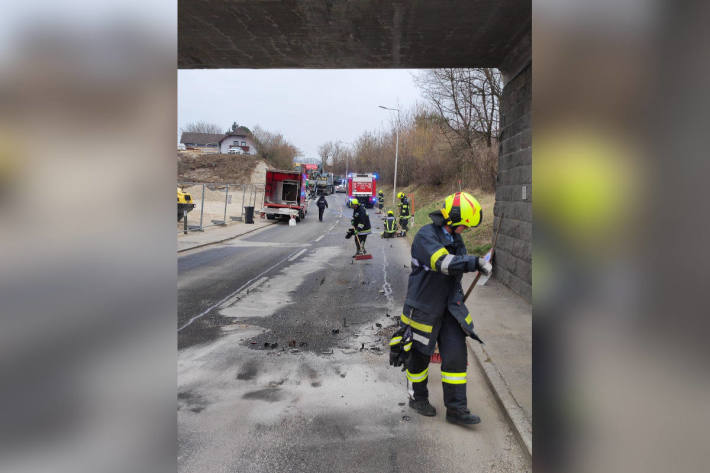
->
[[462, 273, 532, 456]]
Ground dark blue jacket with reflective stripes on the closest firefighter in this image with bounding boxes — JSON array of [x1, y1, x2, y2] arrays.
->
[[401, 211, 480, 351]]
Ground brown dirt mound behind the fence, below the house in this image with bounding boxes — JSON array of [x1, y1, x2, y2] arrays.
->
[[177, 152, 265, 184]]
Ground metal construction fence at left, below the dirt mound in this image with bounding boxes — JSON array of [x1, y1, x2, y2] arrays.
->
[[177, 182, 264, 232]]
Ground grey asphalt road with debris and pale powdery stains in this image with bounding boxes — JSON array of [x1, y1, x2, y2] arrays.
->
[[177, 194, 531, 473]]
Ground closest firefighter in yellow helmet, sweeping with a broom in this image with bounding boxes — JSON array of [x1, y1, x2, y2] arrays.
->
[[390, 192, 492, 425]]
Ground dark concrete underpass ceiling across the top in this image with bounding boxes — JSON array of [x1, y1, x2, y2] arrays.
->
[[178, 0, 531, 69]]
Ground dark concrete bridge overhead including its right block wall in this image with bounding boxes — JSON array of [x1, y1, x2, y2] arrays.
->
[[178, 0, 532, 300]]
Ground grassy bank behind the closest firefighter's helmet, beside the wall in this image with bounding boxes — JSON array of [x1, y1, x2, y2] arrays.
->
[[381, 182, 495, 256]]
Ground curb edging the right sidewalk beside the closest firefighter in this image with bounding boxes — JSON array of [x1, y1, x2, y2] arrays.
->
[[466, 340, 532, 461]]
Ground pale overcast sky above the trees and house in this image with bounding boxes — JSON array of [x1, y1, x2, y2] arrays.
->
[[178, 69, 423, 158]]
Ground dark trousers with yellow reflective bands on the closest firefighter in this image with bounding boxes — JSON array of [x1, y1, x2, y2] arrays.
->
[[407, 312, 467, 409]]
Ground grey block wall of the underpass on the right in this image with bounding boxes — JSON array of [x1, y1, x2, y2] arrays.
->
[[493, 62, 532, 301]]
